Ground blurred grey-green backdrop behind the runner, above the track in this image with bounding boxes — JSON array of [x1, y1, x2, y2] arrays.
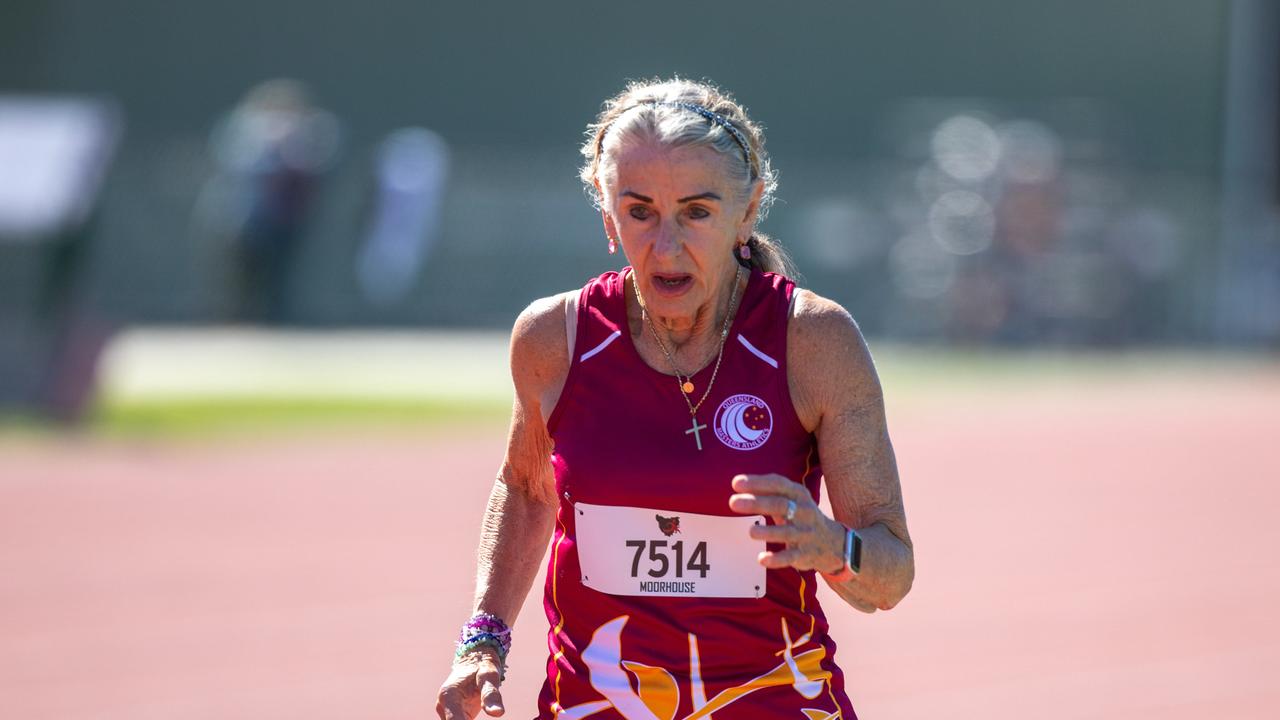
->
[[0, 0, 1280, 415]]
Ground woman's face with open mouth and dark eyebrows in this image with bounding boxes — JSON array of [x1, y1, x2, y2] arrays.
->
[[603, 143, 758, 327]]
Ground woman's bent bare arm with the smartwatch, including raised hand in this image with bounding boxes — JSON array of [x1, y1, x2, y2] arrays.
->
[[730, 290, 915, 612]]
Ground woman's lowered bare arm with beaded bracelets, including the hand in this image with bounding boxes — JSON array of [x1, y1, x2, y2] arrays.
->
[[435, 295, 570, 720]]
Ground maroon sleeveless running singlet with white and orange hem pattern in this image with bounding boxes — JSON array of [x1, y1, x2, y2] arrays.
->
[[538, 268, 856, 720]]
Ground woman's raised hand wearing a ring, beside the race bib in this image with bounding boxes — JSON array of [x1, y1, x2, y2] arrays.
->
[[728, 473, 845, 574]]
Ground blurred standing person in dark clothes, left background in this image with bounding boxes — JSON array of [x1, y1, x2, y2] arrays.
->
[[205, 79, 339, 323]]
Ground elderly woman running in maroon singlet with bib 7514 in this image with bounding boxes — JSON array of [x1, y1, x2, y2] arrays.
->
[[436, 79, 914, 720]]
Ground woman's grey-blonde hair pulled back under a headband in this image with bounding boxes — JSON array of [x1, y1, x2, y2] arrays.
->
[[579, 77, 795, 275]]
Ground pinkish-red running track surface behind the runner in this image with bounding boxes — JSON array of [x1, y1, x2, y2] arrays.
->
[[0, 372, 1280, 720]]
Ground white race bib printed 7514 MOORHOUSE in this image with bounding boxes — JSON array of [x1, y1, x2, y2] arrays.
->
[[573, 502, 764, 597]]
